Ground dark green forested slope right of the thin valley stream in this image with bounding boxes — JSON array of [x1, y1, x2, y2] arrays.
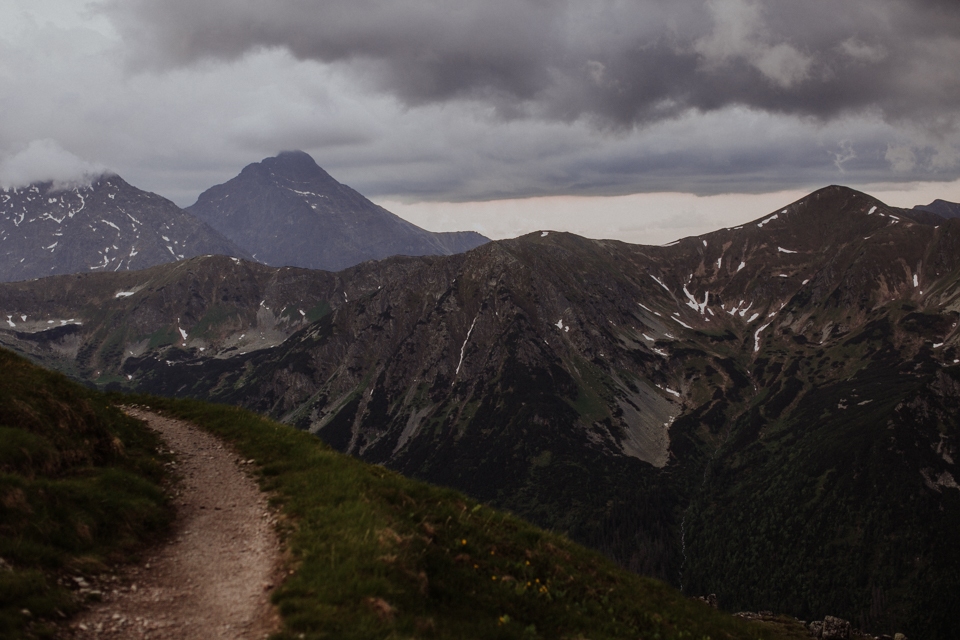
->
[[684, 324, 960, 638]]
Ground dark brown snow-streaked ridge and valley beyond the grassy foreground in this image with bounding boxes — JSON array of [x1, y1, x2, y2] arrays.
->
[[0, 182, 960, 639]]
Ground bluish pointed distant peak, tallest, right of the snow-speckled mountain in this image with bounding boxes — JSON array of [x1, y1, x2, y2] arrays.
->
[[187, 151, 488, 271]]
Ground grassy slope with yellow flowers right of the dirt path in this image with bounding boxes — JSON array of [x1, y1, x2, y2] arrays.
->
[[127, 397, 796, 640]]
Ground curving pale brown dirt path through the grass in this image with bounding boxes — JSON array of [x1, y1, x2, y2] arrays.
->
[[63, 409, 280, 640]]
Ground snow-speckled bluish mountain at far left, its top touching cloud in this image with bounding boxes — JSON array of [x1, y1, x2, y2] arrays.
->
[[0, 175, 249, 281]]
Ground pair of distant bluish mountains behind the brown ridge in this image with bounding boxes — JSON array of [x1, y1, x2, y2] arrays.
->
[[0, 151, 488, 281]]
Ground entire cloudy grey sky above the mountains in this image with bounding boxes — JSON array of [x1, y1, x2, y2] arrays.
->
[[0, 0, 960, 242]]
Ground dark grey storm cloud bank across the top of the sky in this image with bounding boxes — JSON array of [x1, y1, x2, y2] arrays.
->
[[105, 0, 960, 129]]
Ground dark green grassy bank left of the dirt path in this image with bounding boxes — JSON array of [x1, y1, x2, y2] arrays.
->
[[0, 349, 172, 639]]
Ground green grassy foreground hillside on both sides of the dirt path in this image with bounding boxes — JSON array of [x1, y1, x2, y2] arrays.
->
[[0, 350, 796, 639]]
